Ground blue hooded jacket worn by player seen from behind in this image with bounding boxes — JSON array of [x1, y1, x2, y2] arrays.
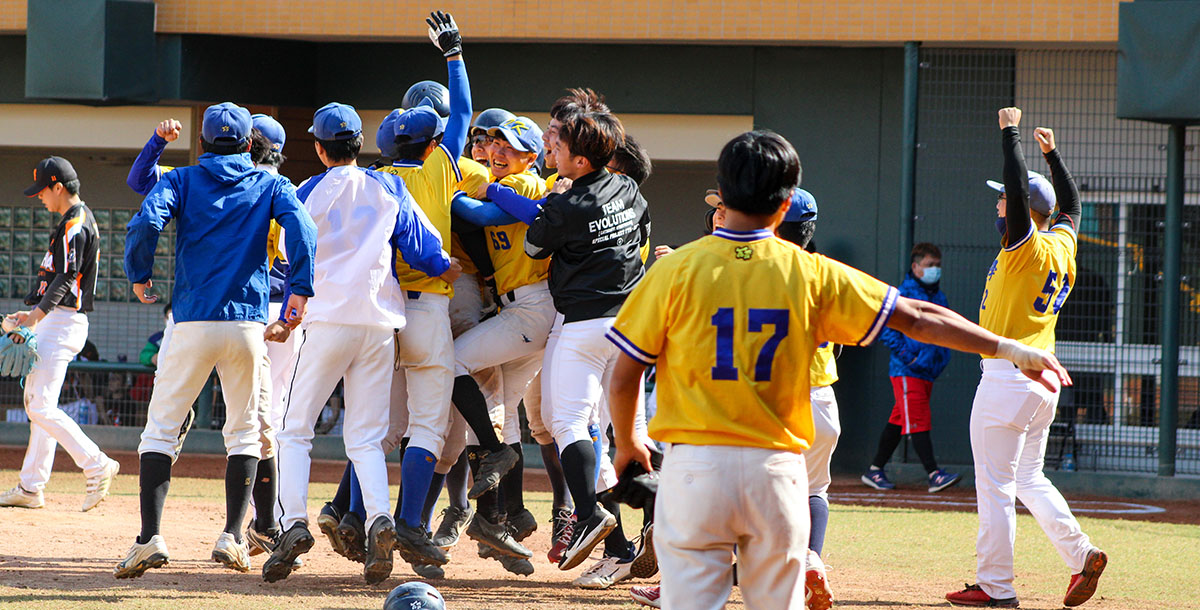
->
[[125, 153, 317, 322]]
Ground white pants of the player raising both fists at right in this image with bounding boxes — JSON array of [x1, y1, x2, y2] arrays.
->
[[971, 358, 1093, 598]]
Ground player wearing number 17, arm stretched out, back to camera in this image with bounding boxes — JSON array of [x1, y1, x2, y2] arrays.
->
[[614, 131, 1069, 610]]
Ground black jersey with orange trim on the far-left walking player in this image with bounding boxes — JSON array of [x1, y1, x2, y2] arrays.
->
[[25, 202, 100, 313]]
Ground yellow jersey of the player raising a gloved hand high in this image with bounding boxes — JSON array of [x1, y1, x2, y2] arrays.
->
[[379, 144, 462, 297]]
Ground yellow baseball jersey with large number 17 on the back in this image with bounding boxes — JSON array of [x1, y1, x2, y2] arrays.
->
[[607, 229, 899, 453]]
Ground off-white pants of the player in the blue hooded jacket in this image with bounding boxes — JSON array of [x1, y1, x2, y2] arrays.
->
[[138, 322, 266, 458]]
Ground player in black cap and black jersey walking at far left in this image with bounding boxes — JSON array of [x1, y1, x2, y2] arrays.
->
[[0, 156, 120, 512]]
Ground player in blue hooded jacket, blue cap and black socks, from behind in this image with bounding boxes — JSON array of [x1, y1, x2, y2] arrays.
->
[[113, 102, 316, 578]]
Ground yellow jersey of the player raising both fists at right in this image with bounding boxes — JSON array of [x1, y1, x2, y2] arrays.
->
[[979, 223, 1078, 358]]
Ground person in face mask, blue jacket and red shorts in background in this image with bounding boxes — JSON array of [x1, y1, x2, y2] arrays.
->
[[862, 243, 960, 494]]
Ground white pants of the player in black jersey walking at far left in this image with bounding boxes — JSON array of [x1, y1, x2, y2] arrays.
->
[[20, 307, 106, 492]]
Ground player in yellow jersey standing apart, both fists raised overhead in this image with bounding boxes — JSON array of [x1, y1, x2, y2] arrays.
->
[[945, 108, 1108, 608]]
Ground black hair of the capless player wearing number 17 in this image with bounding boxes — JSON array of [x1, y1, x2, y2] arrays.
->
[[716, 130, 800, 216]]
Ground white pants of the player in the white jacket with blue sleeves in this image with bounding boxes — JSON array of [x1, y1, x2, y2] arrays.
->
[[278, 322, 397, 531]]
